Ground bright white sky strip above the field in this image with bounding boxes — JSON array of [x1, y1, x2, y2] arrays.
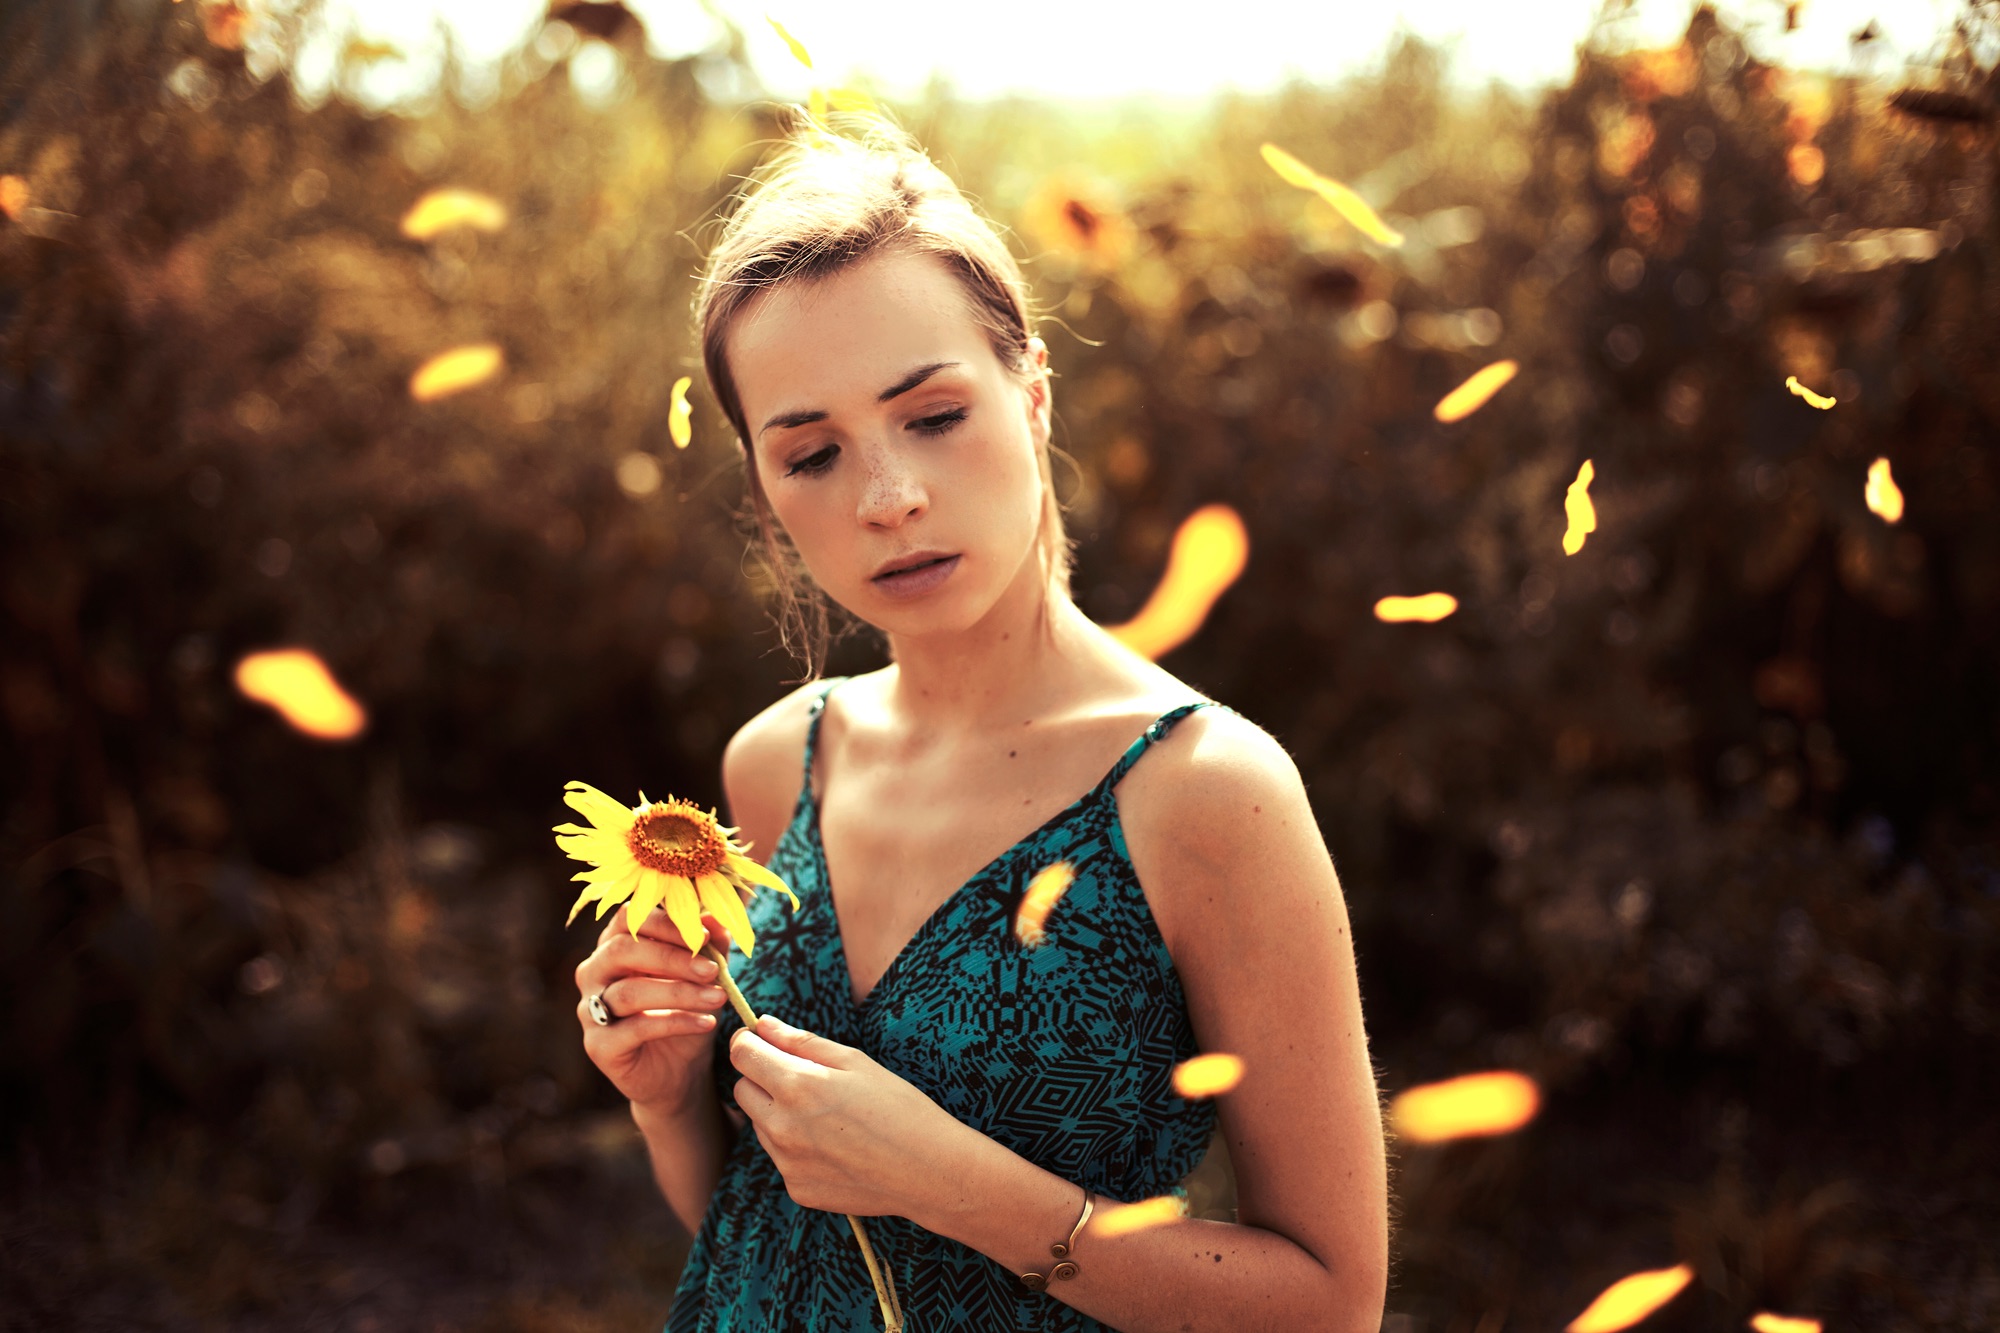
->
[[286, 0, 1960, 102]]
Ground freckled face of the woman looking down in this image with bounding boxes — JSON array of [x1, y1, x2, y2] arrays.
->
[[728, 250, 1048, 636]]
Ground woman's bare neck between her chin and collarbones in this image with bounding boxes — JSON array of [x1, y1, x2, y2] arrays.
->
[[886, 556, 1096, 735]]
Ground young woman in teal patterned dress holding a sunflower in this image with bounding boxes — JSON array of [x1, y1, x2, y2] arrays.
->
[[576, 116, 1388, 1333]]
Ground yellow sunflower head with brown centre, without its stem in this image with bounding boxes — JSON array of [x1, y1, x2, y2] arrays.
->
[[556, 783, 798, 957]]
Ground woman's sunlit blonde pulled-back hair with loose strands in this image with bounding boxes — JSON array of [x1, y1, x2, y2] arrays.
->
[[694, 112, 1070, 677]]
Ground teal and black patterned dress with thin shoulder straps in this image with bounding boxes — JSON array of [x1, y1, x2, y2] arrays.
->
[[666, 681, 1216, 1333]]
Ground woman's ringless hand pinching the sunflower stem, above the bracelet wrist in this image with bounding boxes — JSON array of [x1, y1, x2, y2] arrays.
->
[[730, 1015, 964, 1217]]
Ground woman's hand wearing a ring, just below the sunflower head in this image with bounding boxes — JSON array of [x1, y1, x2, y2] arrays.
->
[[576, 907, 730, 1113]]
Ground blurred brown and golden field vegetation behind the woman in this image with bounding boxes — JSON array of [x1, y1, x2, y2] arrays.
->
[[0, 0, 2000, 1333]]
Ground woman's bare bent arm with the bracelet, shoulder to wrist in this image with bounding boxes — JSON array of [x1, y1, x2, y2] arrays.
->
[[916, 713, 1388, 1333]]
